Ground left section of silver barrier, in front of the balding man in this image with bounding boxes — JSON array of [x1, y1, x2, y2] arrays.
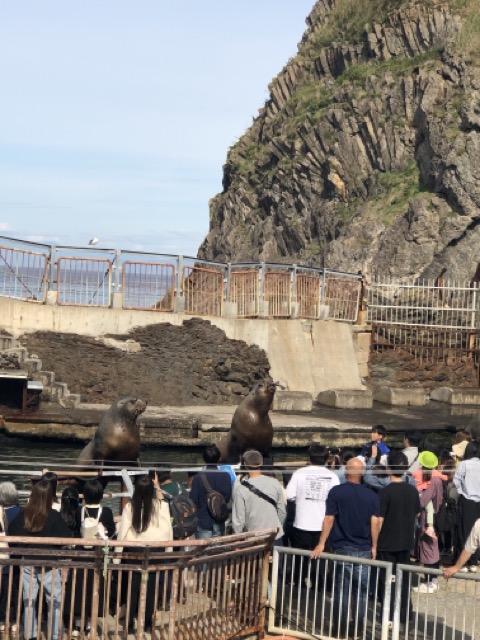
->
[[268, 547, 392, 640]]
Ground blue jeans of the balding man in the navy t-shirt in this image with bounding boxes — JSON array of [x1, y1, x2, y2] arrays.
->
[[334, 547, 372, 635]]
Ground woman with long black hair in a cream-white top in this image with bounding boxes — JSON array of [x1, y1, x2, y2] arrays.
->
[[118, 473, 173, 631]]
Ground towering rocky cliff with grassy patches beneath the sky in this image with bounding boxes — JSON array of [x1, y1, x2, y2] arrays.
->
[[199, 0, 480, 279]]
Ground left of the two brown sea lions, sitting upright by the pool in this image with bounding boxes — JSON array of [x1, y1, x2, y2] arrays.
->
[[77, 396, 147, 467]]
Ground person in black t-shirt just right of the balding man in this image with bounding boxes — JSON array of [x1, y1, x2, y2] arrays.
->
[[377, 451, 421, 623]]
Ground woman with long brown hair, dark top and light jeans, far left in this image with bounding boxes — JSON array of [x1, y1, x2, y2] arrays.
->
[[8, 480, 71, 640]]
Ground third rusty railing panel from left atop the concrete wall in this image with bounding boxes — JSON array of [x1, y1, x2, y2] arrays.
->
[[122, 262, 175, 311]]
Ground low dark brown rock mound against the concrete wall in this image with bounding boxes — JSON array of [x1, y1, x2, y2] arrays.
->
[[20, 319, 270, 406]]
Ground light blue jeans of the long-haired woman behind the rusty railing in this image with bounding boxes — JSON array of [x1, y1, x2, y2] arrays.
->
[[23, 567, 62, 640]]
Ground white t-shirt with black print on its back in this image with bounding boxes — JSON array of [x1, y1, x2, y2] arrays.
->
[[287, 465, 340, 531]]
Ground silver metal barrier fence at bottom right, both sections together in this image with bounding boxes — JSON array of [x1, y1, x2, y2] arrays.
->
[[268, 547, 480, 640]]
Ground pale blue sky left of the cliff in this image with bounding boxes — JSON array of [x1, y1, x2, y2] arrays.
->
[[0, 0, 314, 255]]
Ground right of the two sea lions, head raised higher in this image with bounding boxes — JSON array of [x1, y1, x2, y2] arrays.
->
[[218, 378, 278, 463]]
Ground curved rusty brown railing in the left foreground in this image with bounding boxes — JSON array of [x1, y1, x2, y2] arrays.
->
[[0, 530, 276, 640]]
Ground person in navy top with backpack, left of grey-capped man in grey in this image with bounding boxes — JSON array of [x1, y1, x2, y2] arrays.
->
[[190, 444, 232, 538]]
